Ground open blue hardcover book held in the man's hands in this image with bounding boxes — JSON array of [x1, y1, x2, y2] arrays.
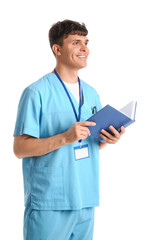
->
[[86, 101, 137, 142]]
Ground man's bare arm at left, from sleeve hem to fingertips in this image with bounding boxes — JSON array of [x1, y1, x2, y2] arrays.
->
[[13, 121, 95, 158]]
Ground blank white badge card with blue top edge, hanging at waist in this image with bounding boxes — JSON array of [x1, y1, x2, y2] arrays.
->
[[74, 144, 89, 160]]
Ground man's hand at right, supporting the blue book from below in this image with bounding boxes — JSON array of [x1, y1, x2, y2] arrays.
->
[[100, 126, 125, 144]]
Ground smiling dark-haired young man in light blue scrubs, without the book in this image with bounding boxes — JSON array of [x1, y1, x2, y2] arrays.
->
[[14, 20, 125, 240]]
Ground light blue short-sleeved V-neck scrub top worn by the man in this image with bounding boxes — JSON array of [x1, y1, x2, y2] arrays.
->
[[14, 73, 101, 210]]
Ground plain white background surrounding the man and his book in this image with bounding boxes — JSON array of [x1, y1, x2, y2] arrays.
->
[[0, 0, 160, 240]]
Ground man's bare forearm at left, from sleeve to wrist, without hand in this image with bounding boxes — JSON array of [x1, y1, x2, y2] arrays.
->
[[14, 133, 67, 158]]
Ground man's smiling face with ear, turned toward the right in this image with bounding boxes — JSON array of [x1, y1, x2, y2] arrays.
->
[[53, 35, 89, 70]]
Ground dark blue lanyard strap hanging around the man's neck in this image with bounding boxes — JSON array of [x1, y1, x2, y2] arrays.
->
[[54, 69, 82, 145]]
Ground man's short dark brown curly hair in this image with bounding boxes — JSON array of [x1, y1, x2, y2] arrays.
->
[[48, 20, 88, 55]]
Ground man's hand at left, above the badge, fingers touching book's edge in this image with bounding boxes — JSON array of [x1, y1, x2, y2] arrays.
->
[[64, 121, 96, 144]]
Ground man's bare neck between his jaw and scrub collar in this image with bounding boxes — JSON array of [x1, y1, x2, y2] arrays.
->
[[53, 65, 78, 83]]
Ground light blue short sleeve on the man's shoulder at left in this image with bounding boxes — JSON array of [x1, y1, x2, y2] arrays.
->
[[14, 86, 41, 138]]
